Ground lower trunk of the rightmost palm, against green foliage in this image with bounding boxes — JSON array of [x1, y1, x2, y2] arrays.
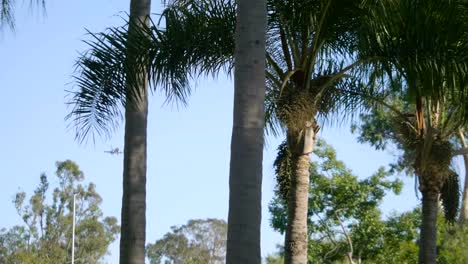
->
[[419, 191, 439, 264]]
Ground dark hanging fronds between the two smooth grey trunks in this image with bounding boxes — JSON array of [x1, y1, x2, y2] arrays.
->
[[150, 0, 236, 95]]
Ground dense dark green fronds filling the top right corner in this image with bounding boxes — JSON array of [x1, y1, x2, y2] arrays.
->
[[359, 0, 468, 119]]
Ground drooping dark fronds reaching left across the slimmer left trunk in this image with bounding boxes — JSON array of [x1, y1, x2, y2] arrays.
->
[[66, 0, 235, 142]]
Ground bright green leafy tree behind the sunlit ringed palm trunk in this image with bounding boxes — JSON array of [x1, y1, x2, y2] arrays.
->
[[269, 140, 402, 263]]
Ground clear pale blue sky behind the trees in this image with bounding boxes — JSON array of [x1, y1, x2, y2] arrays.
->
[[0, 0, 458, 263]]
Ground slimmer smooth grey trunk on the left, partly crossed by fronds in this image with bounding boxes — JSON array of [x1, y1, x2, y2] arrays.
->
[[120, 0, 151, 264]]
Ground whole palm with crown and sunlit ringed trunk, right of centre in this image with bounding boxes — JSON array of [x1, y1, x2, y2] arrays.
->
[[267, 0, 372, 263]]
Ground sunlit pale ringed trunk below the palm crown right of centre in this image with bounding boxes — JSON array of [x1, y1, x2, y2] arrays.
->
[[284, 122, 317, 264]]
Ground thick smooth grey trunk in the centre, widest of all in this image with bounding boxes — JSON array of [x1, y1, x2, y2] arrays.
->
[[226, 0, 266, 264]]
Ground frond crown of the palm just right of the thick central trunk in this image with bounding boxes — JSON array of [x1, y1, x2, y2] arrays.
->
[[266, 0, 376, 132]]
